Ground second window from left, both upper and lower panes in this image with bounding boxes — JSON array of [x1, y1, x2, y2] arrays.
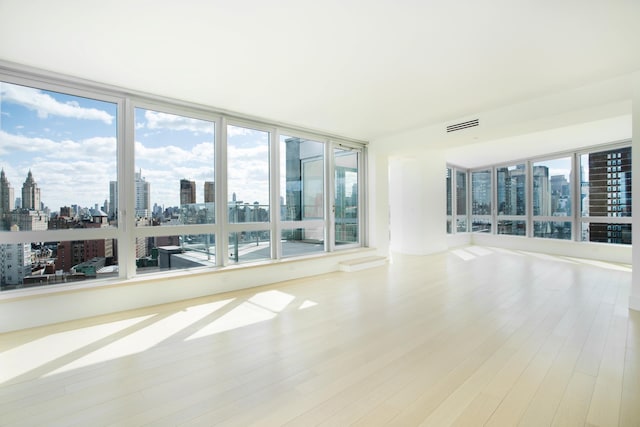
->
[[133, 106, 216, 274]]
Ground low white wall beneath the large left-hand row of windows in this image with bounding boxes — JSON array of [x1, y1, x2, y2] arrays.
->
[[0, 249, 374, 333]]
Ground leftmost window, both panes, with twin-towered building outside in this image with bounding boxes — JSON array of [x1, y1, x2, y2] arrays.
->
[[0, 82, 122, 290]]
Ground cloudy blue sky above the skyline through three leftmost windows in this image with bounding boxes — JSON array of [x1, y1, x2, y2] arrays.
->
[[0, 83, 269, 211]]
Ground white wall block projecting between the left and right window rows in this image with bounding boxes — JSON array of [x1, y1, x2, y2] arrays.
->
[[389, 150, 447, 255]]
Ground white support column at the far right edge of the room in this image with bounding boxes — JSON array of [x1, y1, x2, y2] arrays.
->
[[629, 72, 640, 311]]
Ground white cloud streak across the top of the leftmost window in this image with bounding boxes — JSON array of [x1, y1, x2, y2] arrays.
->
[[0, 83, 114, 125]]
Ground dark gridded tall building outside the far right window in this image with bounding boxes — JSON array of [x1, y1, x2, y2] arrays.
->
[[588, 147, 631, 244]]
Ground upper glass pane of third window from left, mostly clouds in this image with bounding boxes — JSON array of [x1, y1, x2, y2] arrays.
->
[[227, 125, 270, 223]]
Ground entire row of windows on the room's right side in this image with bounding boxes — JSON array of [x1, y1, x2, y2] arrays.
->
[[445, 141, 632, 244]]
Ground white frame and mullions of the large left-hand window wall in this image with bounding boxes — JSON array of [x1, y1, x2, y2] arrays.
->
[[0, 64, 368, 295]]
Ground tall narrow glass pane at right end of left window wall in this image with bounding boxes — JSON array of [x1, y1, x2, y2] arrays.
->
[[334, 148, 359, 245]]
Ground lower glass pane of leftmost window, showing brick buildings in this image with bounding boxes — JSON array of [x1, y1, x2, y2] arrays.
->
[[0, 239, 118, 291]]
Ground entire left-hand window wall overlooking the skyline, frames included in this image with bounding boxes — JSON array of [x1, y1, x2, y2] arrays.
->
[[0, 72, 365, 291]]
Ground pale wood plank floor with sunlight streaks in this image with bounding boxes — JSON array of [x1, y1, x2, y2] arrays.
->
[[0, 247, 640, 426]]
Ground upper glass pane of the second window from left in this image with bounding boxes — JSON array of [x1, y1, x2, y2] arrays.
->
[[135, 108, 215, 226]]
